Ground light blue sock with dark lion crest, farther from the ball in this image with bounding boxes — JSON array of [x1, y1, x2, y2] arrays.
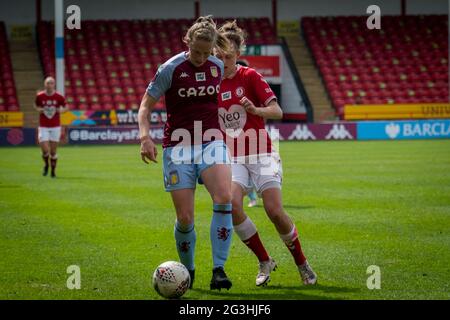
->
[[210, 203, 233, 268]]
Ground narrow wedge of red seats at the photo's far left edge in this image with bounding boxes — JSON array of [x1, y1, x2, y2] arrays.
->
[[0, 22, 19, 111]]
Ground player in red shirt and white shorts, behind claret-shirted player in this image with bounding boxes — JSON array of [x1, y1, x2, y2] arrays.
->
[[216, 21, 317, 286]]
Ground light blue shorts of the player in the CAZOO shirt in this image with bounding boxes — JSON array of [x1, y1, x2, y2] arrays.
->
[[163, 140, 231, 192]]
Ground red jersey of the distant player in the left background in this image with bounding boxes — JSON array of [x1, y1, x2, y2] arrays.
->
[[35, 91, 66, 128]]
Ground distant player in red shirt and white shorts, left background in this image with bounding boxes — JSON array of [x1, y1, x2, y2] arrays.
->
[[34, 77, 68, 178]]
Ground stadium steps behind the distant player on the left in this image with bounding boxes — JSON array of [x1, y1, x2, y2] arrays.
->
[[10, 39, 43, 127]]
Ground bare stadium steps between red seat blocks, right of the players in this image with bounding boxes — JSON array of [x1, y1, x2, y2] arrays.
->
[[286, 36, 336, 122]]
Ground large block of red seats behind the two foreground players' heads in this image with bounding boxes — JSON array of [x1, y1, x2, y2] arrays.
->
[[37, 18, 277, 110]]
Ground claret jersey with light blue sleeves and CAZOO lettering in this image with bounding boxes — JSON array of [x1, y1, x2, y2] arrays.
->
[[147, 52, 224, 148]]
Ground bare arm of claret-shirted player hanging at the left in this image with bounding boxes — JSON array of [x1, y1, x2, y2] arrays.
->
[[138, 92, 158, 163]]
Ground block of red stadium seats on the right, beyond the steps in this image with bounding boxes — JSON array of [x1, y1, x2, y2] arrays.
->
[[301, 15, 449, 117]]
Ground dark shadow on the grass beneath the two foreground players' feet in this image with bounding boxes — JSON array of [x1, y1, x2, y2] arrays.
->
[[186, 284, 359, 300]]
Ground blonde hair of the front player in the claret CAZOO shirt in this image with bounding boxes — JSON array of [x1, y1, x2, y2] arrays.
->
[[183, 15, 230, 51]]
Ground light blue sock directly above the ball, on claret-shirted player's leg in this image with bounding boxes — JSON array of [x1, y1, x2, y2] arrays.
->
[[174, 221, 197, 270]]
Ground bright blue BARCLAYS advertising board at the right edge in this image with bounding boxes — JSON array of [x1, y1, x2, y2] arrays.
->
[[357, 120, 450, 140]]
